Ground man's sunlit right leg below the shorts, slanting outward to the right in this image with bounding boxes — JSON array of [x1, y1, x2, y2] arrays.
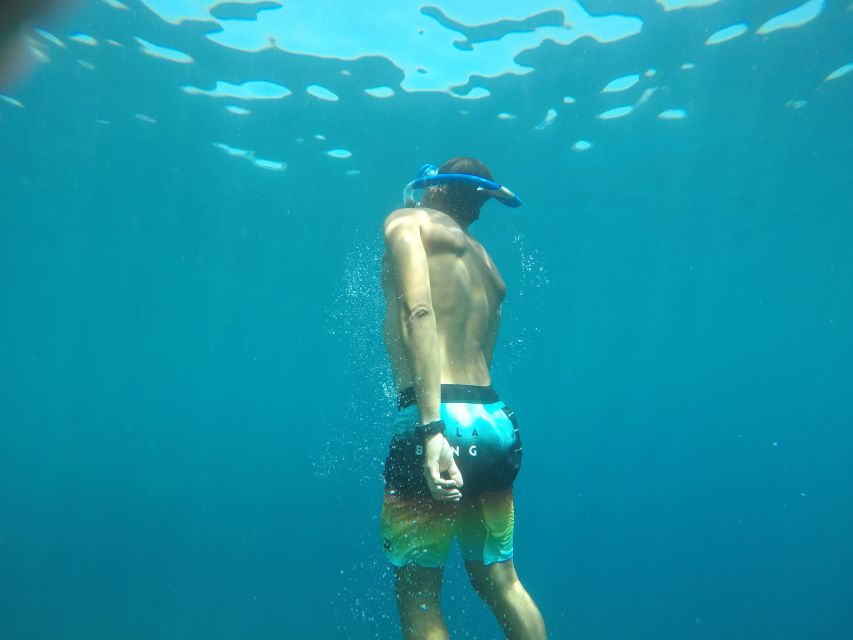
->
[[465, 560, 547, 640]]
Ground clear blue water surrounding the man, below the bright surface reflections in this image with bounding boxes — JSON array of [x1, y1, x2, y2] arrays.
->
[[0, 1, 853, 640]]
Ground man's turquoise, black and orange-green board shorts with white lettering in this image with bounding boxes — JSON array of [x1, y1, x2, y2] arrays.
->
[[380, 384, 521, 567]]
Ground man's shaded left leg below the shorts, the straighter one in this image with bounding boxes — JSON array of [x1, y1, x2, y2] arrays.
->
[[394, 564, 449, 640]]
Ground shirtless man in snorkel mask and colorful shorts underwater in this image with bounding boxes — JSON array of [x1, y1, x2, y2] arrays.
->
[[380, 158, 546, 640]]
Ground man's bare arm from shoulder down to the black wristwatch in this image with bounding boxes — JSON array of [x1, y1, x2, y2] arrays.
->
[[385, 213, 441, 424]]
